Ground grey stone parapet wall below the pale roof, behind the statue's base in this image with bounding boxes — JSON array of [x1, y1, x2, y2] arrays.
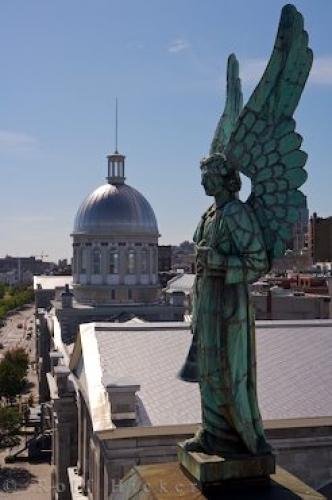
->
[[101, 427, 332, 493]]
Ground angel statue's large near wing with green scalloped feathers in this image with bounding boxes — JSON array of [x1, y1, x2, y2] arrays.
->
[[226, 5, 313, 259]]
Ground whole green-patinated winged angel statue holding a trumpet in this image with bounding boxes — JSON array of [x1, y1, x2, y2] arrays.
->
[[180, 5, 312, 458]]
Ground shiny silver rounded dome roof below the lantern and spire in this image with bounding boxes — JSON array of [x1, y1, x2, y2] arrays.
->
[[73, 184, 158, 236]]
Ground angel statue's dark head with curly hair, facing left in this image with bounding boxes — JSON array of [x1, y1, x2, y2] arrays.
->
[[201, 153, 241, 196]]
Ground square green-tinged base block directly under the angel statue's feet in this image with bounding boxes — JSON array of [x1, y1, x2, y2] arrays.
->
[[178, 443, 275, 487]]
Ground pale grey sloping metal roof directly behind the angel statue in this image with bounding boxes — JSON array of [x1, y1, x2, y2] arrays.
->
[[76, 321, 332, 426]]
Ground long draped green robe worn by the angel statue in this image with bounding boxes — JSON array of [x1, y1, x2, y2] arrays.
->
[[192, 199, 270, 456]]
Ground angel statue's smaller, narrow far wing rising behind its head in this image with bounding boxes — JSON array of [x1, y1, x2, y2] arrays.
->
[[210, 54, 243, 155]]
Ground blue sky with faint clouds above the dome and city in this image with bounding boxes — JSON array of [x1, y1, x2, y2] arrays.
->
[[0, 0, 332, 259]]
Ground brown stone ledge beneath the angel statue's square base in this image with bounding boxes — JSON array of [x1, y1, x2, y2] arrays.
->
[[118, 462, 325, 500]]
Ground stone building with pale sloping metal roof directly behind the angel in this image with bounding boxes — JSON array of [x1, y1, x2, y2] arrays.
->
[[48, 319, 332, 500]]
